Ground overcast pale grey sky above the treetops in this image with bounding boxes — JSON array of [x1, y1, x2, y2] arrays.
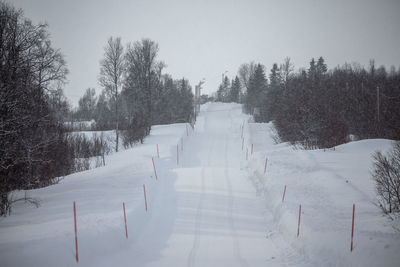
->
[[9, 0, 400, 105]]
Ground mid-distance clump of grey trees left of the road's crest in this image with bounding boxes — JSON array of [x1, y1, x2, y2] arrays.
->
[[74, 37, 194, 150]]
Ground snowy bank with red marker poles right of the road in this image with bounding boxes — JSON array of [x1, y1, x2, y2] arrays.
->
[[245, 123, 400, 266]]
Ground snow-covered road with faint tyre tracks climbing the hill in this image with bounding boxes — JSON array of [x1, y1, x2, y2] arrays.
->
[[126, 105, 305, 267]]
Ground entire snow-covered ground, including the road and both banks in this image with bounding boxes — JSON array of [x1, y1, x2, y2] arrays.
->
[[0, 103, 400, 267]]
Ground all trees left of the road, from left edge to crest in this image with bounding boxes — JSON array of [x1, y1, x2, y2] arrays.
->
[[0, 1, 193, 216]]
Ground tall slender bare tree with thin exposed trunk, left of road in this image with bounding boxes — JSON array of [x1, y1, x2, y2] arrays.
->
[[99, 37, 125, 152]]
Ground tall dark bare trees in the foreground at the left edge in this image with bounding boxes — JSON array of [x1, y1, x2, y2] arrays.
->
[[0, 1, 72, 215]]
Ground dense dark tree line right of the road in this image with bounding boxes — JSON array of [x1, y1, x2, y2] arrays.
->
[[217, 57, 400, 148]]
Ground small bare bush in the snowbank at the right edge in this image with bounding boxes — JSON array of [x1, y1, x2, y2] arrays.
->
[[372, 141, 400, 213]]
